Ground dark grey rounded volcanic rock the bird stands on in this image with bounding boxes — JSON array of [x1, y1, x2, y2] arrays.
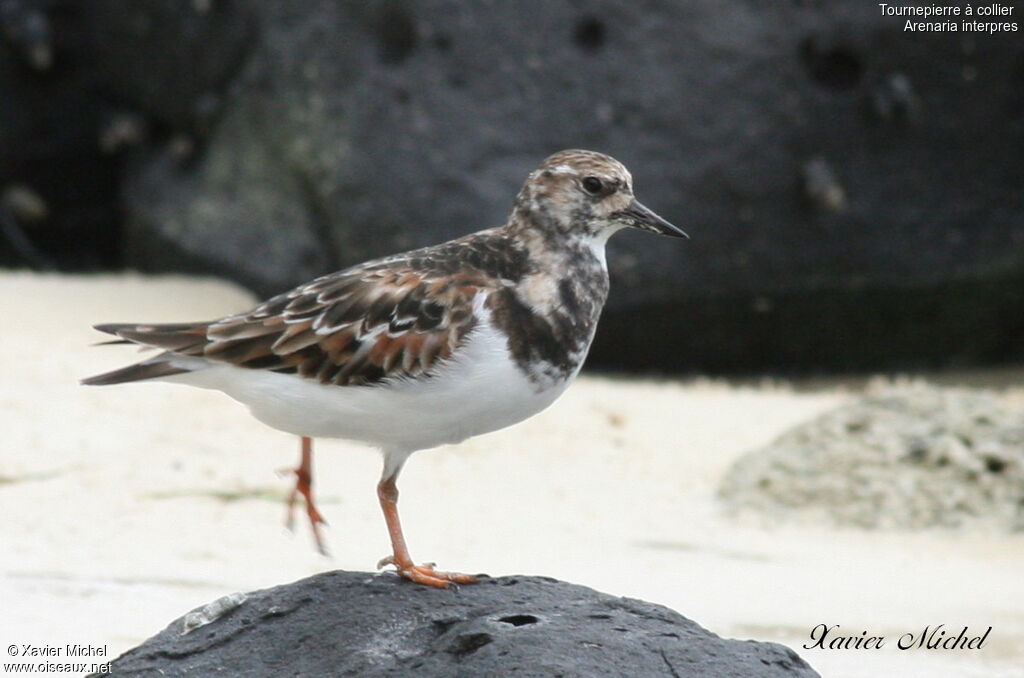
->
[[92, 571, 818, 678]]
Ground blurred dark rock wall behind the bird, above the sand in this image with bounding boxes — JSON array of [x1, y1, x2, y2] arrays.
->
[[0, 0, 1024, 372]]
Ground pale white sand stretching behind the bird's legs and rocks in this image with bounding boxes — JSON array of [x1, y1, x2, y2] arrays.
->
[[0, 273, 1024, 678]]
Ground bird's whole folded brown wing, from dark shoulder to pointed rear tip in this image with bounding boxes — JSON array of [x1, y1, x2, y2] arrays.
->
[[89, 229, 530, 385]]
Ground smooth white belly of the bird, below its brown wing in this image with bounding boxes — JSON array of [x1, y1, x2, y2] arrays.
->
[[167, 320, 571, 453]]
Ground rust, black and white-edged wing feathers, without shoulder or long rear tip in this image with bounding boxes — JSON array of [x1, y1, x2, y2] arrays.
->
[[192, 265, 494, 386]]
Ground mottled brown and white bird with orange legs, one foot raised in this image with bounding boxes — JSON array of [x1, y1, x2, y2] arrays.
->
[[82, 150, 688, 588]]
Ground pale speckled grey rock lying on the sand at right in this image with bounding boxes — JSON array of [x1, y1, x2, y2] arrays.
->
[[720, 386, 1024, 533]]
